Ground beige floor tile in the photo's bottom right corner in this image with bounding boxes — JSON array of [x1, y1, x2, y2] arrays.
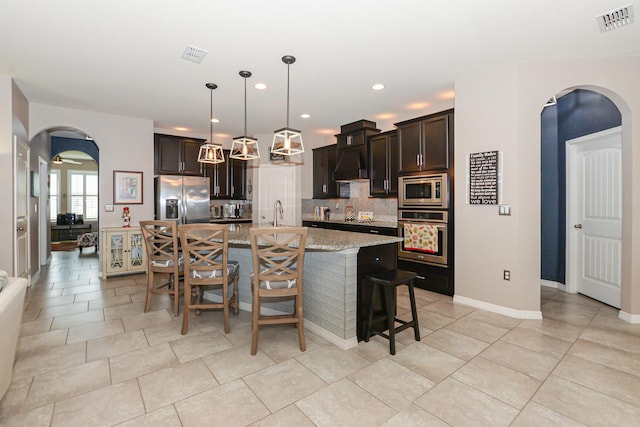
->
[[532, 375, 640, 426]]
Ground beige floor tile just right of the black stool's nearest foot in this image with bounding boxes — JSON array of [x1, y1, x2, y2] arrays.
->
[[393, 343, 466, 383]]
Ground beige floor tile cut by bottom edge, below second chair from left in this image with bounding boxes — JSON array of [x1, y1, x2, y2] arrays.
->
[[175, 380, 269, 427]]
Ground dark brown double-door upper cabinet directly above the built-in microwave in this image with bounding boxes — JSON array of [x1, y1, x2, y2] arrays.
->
[[396, 110, 453, 175]]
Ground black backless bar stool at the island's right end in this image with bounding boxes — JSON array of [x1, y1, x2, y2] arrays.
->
[[364, 270, 420, 355]]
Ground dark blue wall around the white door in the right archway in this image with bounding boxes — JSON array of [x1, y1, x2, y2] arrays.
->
[[540, 89, 622, 283]]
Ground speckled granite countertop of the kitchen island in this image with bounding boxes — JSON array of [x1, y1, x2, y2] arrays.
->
[[229, 223, 402, 251]]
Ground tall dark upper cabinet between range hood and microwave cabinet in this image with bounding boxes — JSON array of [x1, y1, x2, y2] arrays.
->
[[369, 130, 398, 197]]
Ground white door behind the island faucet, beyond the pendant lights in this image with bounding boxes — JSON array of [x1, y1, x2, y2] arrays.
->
[[254, 165, 301, 226]]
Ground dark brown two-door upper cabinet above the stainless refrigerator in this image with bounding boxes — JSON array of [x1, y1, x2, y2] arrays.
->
[[154, 133, 204, 175]]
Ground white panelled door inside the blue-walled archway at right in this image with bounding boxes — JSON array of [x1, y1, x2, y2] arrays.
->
[[567, 127, 622, 308]]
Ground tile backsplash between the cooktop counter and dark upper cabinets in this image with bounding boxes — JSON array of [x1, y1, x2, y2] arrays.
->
[[302, 181, 398, 222]]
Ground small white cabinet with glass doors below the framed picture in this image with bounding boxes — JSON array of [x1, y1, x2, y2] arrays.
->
[[101, 227, 147, 279]]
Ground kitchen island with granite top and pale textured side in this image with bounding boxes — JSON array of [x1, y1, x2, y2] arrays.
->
[[210, 224, 400, 349]]
